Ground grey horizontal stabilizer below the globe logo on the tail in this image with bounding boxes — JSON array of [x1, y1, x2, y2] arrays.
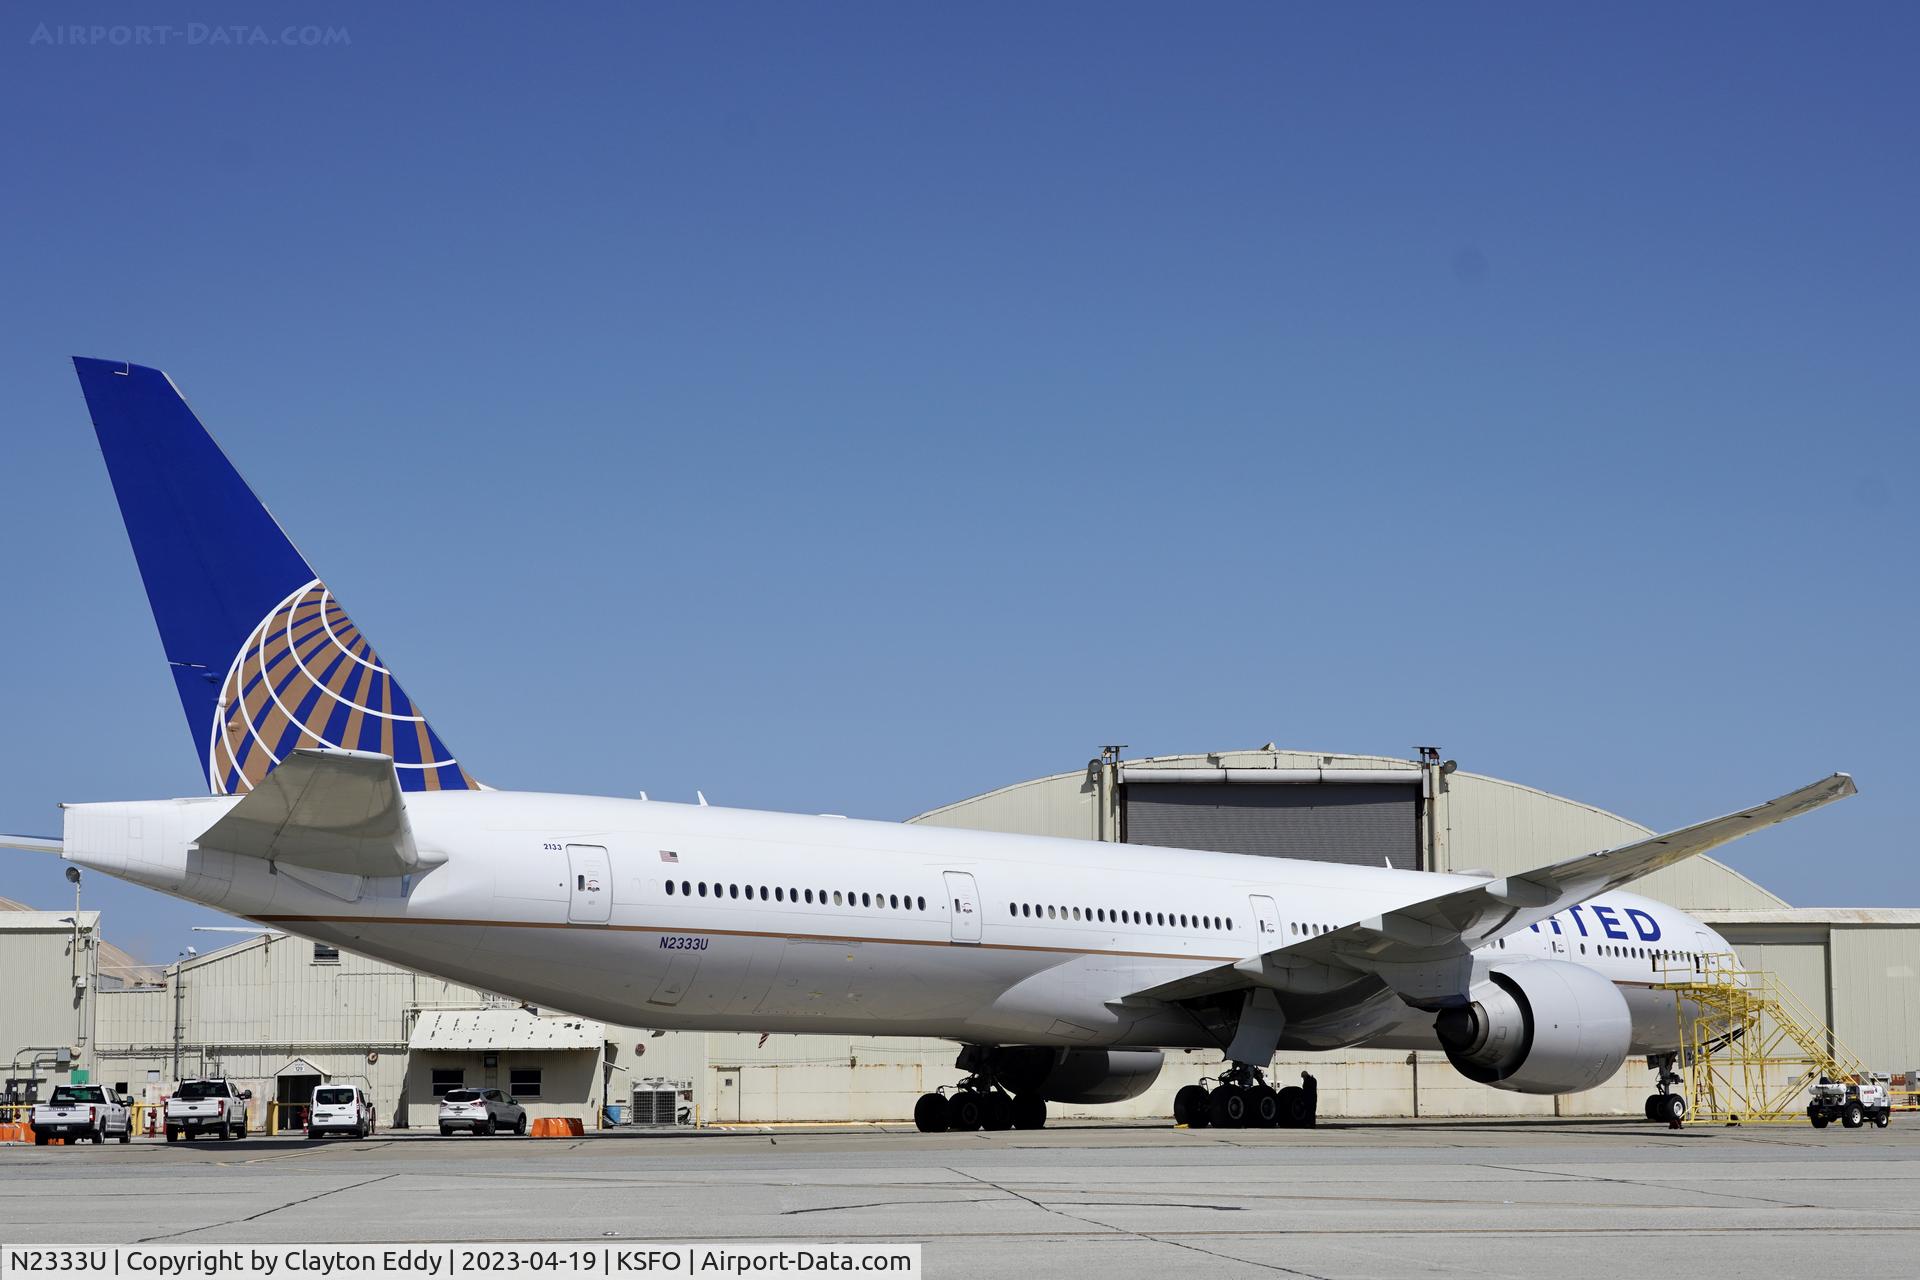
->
[[200, 748, 422, 875]]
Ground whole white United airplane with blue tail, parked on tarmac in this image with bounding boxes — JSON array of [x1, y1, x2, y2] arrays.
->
[[4, 359, 1855, 1132]]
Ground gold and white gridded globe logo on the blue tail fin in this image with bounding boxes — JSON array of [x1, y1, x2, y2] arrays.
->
[[207, 580, 478, 794]]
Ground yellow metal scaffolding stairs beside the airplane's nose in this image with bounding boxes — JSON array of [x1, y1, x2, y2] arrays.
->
[[1657, 952, 1866, 1125]]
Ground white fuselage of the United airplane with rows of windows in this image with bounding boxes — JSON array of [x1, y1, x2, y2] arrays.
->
[[65, 791, 1728, 1054]]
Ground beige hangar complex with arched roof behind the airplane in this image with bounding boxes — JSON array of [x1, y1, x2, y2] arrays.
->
[[0, 745, 1920, 1126]]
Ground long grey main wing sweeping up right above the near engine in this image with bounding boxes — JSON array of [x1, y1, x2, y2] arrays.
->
[[1129, 773, 1855, 1000]]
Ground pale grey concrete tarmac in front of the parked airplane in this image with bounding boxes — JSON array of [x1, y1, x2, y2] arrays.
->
[[0, 1115, 1920, 1280]]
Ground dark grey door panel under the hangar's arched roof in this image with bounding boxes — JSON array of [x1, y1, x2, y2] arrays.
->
[[1119, 770, 1421, 871]]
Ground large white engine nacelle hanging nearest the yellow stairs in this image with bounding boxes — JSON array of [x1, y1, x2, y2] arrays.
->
[[1434, 960, 1634, 1094]]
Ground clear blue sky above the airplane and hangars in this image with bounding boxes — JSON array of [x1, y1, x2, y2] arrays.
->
[[0, 0, 1920, 958]]
